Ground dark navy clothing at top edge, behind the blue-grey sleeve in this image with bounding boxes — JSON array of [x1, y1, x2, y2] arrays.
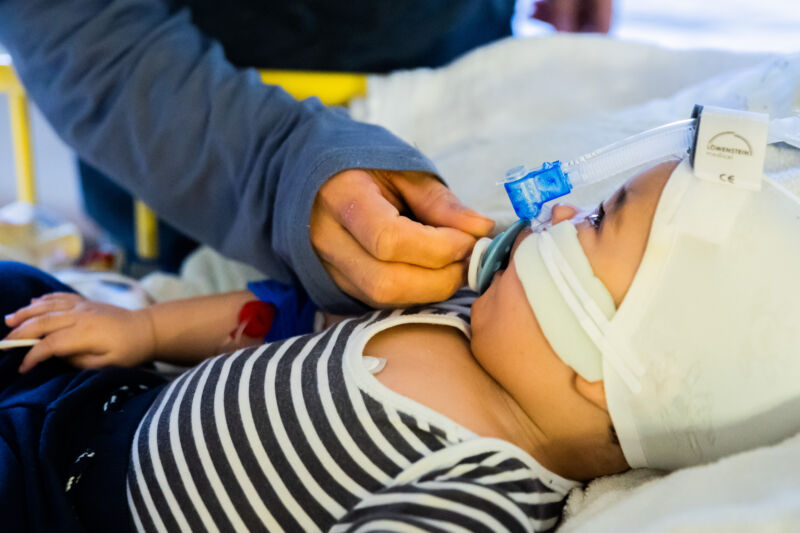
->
[[183, 0, 515, 72]]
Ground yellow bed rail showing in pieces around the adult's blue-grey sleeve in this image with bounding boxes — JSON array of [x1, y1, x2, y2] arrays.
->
[[0, 60, 367, 259]]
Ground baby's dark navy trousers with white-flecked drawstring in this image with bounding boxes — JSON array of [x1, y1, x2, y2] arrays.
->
[[0, 262, 164, 533]]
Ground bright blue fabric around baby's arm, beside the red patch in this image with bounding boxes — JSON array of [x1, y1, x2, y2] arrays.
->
[[247, 280, 317, 342]]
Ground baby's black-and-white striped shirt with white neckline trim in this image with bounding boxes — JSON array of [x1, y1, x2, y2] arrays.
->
[[127, 292, 577, 532]]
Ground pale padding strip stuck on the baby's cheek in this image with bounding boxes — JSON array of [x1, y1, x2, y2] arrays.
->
[[514, 221, 614, 381]]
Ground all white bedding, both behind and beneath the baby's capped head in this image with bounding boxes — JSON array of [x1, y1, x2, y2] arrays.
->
[[351, 36, 800, 532]]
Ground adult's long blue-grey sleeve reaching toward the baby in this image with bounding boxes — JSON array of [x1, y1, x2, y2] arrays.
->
[[0, 0, 435, 314]]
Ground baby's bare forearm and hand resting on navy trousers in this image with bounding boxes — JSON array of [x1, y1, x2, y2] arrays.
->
[[6, 291, 261, 372]]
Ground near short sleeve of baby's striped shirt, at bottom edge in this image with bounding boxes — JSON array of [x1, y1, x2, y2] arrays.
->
[[330, 448, 566, 533]]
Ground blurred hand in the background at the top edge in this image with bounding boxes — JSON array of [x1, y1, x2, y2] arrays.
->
[[531, 0, 612, 33]]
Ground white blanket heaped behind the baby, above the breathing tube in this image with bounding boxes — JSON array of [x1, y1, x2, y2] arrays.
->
[[351, 35, 800, 226]]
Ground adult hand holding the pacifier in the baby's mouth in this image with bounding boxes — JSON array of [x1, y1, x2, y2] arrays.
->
[[310, 169, 494, 307]]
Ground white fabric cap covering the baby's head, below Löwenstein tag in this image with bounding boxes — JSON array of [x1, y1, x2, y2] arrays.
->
[[603, 161, 800, 470]]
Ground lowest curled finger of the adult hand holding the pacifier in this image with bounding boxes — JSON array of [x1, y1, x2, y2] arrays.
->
[[318, 217, 465, 307]]
